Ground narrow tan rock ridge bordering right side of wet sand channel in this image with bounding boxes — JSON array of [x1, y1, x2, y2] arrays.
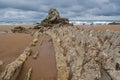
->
[[46, 29, 69, 80]]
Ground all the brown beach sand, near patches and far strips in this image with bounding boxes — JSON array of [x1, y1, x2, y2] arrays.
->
[[0, 24, 120, 80]]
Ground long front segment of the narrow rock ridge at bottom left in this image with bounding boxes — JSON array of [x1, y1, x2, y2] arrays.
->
[[0, 47, 31, 80]]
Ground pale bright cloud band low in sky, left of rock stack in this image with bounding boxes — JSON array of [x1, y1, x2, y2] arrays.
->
[[0, 8, 43, 19]]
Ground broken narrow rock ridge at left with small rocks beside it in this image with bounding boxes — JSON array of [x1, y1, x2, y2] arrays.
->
[[0, 31, 39, 80]]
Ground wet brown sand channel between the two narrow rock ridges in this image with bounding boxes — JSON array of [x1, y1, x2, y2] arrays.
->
[[17, 34, 57, 80]]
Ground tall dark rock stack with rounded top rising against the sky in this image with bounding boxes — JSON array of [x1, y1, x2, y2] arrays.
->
[[34, 8, 71, 32]]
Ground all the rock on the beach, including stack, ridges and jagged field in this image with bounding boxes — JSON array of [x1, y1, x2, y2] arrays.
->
[[0, 8, 120, 80]]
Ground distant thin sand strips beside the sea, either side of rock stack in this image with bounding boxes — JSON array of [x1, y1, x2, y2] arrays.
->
[[0, 23, 120, 34]]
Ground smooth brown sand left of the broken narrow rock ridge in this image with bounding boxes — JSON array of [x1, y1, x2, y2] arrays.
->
[[0, 34, 32, 70]]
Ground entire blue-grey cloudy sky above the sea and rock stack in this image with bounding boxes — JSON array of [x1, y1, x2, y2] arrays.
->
[[0, 0, 120, 20]]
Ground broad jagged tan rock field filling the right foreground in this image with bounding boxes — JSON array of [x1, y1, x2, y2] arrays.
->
[[47, 26, 120, 80]]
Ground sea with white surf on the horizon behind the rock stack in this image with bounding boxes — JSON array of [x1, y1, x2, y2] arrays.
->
[[0, 19, 120, 25]]
